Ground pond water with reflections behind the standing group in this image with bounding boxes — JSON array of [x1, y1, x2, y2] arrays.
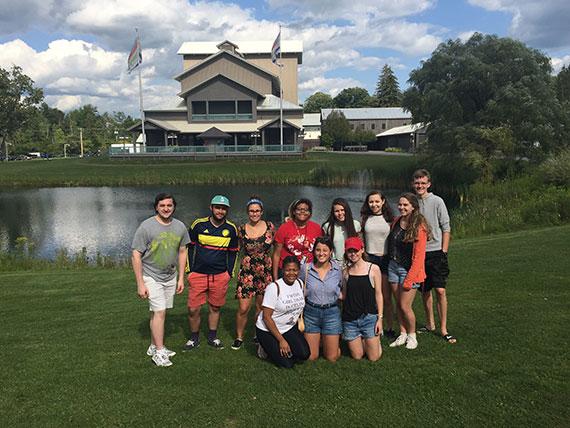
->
[[0, 185, 397, 258]]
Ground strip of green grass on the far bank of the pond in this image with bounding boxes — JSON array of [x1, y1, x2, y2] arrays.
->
[[0, 153, 415, 188]]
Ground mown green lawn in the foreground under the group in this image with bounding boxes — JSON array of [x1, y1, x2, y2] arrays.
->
[[0, 226, 570, 427]]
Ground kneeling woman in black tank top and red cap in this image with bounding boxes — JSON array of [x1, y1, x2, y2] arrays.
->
[[342, 238, 383, 361]]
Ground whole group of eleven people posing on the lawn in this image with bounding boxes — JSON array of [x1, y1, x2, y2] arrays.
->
[[132, 170, 456, 368]]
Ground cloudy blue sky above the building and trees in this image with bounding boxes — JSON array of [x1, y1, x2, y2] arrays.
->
[[0, 0, 570, 117]]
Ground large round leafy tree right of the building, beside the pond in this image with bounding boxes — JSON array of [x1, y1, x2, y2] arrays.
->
[[403, 33, 564, 178]]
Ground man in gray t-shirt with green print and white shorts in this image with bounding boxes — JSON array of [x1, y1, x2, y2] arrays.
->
[[131, 193, 190, 367]]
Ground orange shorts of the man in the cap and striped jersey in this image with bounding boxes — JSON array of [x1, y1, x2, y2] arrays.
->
[[188, 272, 230, 308]]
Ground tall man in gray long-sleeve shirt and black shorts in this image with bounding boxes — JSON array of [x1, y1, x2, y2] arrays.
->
[[413, 169, 457, 343]]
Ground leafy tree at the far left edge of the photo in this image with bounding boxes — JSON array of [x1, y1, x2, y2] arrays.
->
[[0, 66, 43, 157]]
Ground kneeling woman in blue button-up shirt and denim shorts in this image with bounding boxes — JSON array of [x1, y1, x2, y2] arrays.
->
[[300, 237, 342, 361]]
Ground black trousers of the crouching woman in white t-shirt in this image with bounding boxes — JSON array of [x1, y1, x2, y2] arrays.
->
[[255, 324, 311, 369]]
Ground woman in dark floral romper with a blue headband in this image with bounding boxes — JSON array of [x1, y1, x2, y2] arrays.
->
[[232, 196, 275, 350]]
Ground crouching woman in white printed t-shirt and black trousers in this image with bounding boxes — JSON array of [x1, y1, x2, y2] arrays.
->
[[255, 256, 311, 369]]
